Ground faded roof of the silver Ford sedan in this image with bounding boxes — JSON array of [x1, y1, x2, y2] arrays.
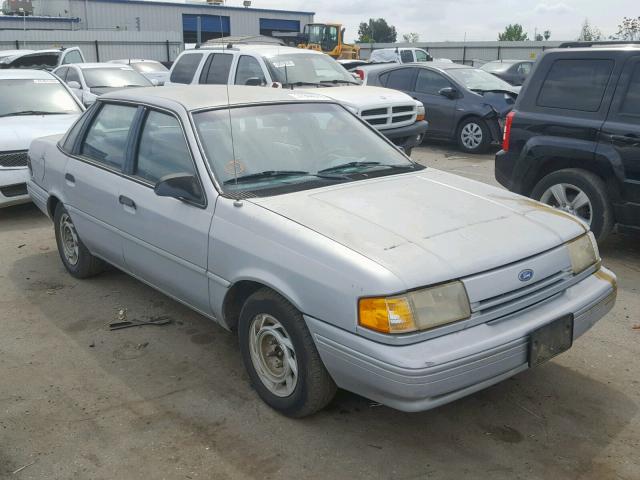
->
[[100, 85, 335, 111]]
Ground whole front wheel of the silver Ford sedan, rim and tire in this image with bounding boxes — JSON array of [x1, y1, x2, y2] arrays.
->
[[238, 288, 336, 418]]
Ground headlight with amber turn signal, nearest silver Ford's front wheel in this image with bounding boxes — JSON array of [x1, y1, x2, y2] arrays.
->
[[358, 281, 471, 333]]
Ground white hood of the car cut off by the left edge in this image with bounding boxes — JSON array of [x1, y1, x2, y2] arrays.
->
[[0, 114, 80, 152]]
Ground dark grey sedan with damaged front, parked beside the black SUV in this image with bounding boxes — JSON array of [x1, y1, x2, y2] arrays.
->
[[357, 62, 520, 153]]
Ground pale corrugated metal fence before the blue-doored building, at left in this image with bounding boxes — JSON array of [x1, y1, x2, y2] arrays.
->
[[0, 30, 184, 62]]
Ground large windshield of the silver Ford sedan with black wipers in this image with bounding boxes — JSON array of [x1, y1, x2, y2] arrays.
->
[[193, 103, 424, 196]]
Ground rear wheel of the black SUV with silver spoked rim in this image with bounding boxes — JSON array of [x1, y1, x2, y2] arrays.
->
[[531, 168, 614, 241]]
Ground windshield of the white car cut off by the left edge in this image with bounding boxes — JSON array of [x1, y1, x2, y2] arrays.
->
[[0, 78, 82, 117]]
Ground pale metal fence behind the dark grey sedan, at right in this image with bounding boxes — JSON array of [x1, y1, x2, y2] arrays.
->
[[360, 42, 562, 66]]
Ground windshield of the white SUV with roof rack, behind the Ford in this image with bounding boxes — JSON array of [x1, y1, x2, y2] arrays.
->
[[267, 53, 358, 85]]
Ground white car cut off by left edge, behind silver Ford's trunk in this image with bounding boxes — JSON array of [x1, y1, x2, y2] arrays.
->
[[0, 70, 84, 207]]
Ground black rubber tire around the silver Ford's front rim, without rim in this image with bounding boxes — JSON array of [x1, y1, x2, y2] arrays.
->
[[238, 288, 336, 418]]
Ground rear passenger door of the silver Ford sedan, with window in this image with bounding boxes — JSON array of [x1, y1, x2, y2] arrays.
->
[[64, 103, 137, 268]]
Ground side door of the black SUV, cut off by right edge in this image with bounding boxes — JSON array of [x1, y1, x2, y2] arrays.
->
[[598, 56, 640, 226]]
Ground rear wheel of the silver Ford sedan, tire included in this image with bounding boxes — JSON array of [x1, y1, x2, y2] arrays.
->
[[53, 203, 105, 278]]
